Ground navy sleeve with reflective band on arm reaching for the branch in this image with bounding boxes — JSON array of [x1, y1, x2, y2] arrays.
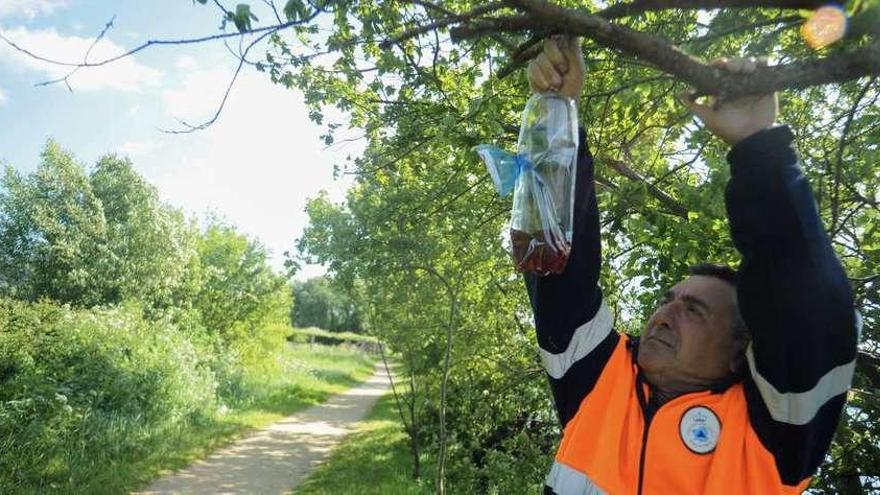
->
[[726, 127, 860, 485]]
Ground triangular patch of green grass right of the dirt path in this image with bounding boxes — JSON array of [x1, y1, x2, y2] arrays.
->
[[293, 388, 434, 495]]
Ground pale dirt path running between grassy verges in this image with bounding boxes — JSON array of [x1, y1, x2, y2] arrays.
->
[[136, 365, 389, 495]]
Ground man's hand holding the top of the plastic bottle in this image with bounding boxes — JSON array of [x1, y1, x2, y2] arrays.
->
[[528, 36, 587, 101]]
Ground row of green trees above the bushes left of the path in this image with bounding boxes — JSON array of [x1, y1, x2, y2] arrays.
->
[[0, 141, 292, 336]]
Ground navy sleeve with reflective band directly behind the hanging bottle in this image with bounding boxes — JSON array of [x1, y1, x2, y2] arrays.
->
[[525, 129, 619, 426]]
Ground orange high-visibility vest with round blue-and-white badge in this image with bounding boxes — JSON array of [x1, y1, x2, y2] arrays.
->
[[547, 336, 809, 495]]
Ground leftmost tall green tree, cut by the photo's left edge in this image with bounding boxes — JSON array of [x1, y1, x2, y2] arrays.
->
[[0, 141, 107, 305]]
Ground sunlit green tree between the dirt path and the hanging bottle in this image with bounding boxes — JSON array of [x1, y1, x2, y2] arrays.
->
[[299, 146, 555, 491]]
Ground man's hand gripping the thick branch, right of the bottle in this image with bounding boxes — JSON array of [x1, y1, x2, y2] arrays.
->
[[682, 58, 778, 146]]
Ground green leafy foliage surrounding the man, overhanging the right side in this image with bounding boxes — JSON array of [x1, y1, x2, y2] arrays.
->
[[280, 1, 880, 493]]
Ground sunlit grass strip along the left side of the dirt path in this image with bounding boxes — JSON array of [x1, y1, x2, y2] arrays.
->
[[91, 345, 374, 494]]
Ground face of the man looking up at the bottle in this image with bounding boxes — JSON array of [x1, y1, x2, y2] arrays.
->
[[638, 275, 741, 392]]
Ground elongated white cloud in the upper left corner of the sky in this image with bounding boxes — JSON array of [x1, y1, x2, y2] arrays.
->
[[0, 26, 162, 91]]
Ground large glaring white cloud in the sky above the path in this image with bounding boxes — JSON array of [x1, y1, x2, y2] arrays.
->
[[136, 68, 362, 276]]
